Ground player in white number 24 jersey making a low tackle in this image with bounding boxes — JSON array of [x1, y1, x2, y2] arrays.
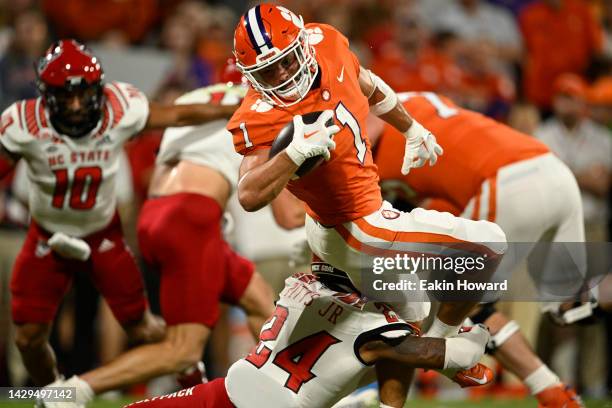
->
[[122, 270, 489, 408]]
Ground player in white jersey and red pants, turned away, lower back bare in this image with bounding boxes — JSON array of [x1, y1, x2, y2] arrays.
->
[[41, 78, 274, 407]]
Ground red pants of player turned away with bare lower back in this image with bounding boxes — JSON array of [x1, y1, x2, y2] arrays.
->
[[138, 193, 254, 328]]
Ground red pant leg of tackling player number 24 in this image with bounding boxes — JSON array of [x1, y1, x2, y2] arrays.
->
[[124, 378, 234, 408]]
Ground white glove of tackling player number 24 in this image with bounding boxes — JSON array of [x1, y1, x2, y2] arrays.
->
[[444, 324, 491, 370]]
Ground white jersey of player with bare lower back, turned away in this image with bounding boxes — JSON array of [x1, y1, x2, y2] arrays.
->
[[156, 84, 246, 190]]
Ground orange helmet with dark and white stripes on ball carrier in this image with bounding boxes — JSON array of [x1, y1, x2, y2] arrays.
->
[[234, 3, 319, 106]]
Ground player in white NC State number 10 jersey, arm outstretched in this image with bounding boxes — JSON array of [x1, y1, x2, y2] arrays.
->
[[0, 40, 238, 385]]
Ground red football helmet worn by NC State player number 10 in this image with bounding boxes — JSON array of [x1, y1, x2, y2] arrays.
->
[[36, 40, 104, 137]]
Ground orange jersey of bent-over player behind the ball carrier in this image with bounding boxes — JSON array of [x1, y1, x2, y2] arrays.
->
[[375, 92, 549, 213]]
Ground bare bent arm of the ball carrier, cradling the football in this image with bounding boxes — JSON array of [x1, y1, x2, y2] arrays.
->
[[238, 149, 298, 211]]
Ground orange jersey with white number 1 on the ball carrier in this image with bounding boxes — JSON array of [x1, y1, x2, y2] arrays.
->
[[227, 24, 382, 226]]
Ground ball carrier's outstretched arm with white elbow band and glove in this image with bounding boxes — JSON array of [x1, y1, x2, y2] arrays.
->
[[359, 67, 443, 175]]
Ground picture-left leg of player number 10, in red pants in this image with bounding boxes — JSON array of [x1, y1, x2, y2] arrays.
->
[[11, 221, 71, 386]]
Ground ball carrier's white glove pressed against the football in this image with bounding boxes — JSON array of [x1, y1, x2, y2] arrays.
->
[[285, 109, 340, 166]]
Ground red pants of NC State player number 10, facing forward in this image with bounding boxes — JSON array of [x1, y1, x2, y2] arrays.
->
[[11, 216, 147, 324]]
